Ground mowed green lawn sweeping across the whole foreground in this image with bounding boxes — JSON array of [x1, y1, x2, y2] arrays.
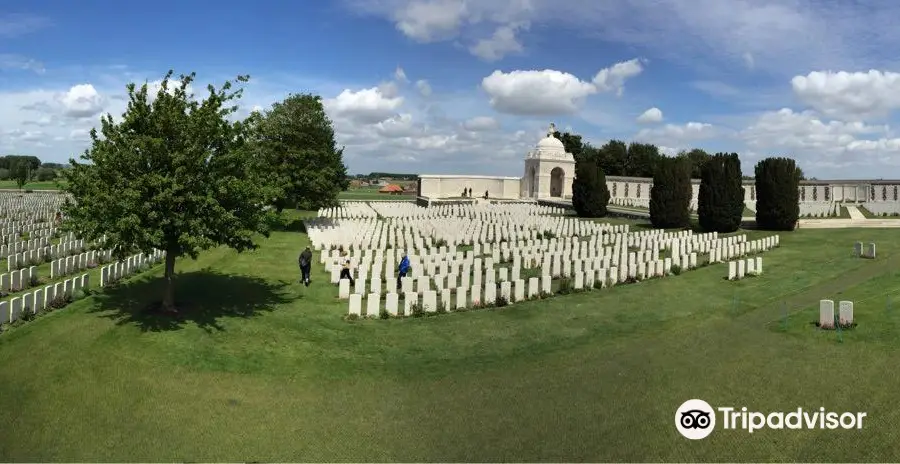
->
[[0, 210, 900, 462]]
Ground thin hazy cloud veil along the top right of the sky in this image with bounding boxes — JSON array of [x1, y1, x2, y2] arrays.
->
[[344, 0, 900, 76]]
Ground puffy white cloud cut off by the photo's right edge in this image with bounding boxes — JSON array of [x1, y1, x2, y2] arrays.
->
[[791, 70, 900, 119]]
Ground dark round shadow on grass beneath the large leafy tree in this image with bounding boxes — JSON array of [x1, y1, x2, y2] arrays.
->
[[91, 268, 295, 332]]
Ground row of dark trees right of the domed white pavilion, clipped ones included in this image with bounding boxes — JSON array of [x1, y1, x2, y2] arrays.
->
[[568, 132, 803, 233]]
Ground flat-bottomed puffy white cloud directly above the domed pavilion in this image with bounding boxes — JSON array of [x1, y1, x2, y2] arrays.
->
[[481, 69, 597, 116]]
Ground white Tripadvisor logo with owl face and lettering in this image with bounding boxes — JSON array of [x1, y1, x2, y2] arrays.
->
[[675, 399, 867, 440]]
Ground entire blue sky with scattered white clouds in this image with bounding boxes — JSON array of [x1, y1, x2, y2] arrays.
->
[[0, 0, 900, 178]]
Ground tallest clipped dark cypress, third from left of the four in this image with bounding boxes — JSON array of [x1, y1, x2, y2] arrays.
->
[[697, 153, 744, 233]]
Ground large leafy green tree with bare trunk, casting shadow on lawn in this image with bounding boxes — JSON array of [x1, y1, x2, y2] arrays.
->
[[63, 71, 274, 312]]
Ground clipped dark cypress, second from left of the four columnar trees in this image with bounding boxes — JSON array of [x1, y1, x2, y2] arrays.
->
[[650, 157, 693, 229]]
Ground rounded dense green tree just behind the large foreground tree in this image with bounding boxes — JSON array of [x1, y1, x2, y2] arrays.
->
[[253, 94, 350, 212]]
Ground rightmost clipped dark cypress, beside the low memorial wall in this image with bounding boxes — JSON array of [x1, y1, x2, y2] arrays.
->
[[755, 158, 801, 230]]
